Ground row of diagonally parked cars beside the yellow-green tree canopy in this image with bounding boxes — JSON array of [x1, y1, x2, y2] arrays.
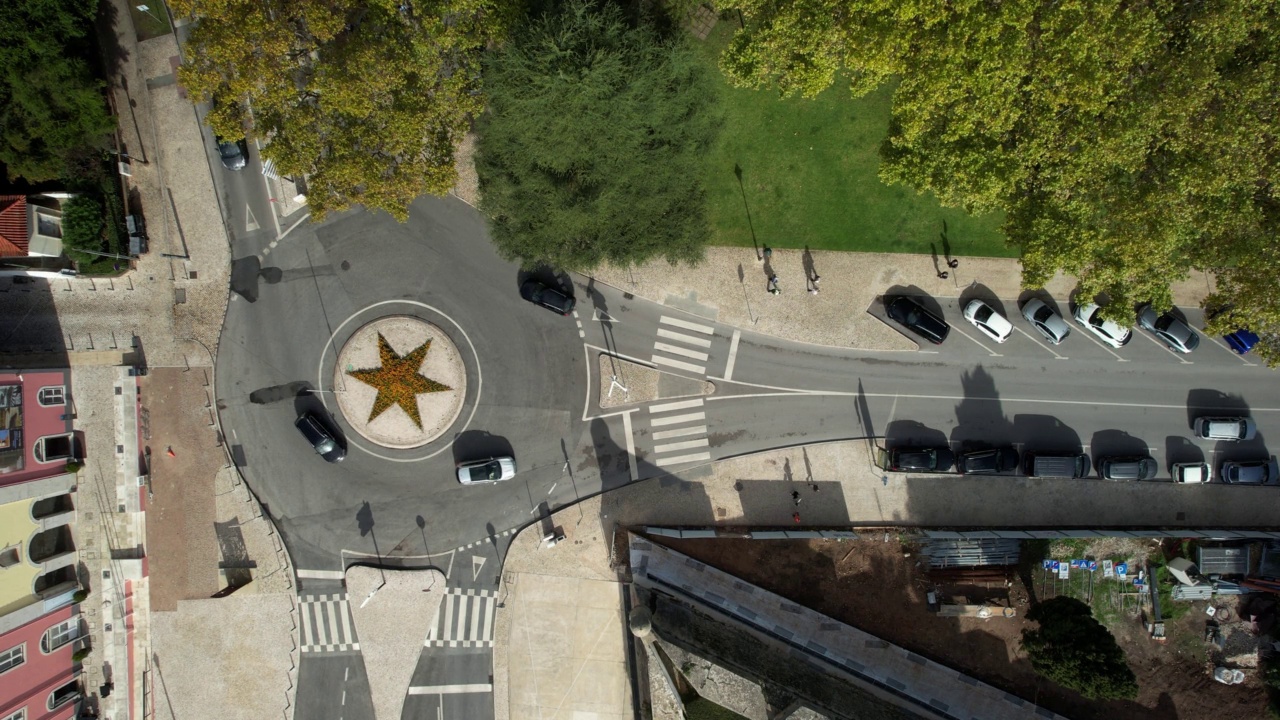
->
[[884, 295, 1258, 355]]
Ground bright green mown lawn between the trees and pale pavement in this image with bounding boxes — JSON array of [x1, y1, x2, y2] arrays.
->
[[695, 20, 1018, 258]]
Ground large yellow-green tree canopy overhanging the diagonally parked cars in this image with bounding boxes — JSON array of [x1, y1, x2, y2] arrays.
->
[[721, 0, 1280, 364]]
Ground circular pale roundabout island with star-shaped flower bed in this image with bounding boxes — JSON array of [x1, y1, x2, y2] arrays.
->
[[333, 315, 467, 448]]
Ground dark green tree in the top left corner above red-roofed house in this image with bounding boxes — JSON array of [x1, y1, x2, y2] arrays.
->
[[0, 0, 115, 182]]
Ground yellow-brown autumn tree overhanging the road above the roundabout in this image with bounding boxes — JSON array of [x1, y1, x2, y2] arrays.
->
[[172, 0, 517, 220]]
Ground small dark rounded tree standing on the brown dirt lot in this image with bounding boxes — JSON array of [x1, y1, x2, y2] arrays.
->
[[1023, 596, 1138, 700]]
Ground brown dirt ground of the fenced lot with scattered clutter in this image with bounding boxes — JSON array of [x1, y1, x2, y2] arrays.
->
[[650, 532, 1266, 720]]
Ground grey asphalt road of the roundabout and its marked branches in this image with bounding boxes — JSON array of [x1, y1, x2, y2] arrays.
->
[[215, 193, 1280, 719]]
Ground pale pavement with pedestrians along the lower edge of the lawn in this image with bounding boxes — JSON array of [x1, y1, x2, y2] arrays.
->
[[590, 247, 1211, 351]]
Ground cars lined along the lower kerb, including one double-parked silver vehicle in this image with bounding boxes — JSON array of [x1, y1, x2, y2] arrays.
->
[[888, 416, 1280, 486]]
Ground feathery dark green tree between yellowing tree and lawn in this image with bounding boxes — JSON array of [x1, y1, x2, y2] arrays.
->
[[476, 0, 718, 269]]
